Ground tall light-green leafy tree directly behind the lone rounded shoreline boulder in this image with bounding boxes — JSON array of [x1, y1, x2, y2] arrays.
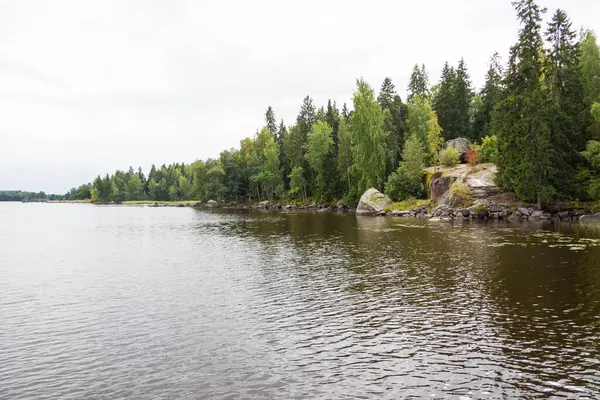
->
[[350, 79, 388, 193]]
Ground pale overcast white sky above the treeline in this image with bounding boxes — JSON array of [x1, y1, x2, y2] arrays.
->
[[0, 0, 600, 193]]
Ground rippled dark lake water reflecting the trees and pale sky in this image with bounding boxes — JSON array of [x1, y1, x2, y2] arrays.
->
[[0, 203, 600, 399]]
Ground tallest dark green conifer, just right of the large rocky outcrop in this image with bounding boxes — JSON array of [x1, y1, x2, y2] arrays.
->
[[494, 0, 555, 206]]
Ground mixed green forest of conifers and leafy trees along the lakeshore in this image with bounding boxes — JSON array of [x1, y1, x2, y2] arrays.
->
[[66, 0, 600, 206]]
